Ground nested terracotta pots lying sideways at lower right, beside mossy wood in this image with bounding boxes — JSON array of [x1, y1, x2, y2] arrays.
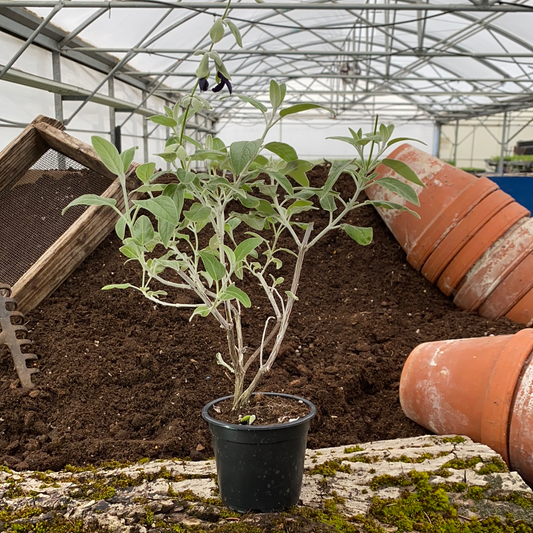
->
[[400, 329, 533, 484]]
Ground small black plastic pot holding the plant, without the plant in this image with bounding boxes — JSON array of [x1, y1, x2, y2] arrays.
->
[[202, 393, 316, 513]]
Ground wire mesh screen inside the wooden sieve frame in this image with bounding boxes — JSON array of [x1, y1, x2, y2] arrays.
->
[[0, 149, 111, 286]]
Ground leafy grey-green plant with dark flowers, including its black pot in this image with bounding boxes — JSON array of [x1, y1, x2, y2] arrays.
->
[[63, 1, 423, 511]]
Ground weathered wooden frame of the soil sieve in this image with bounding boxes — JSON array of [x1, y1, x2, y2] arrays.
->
[[0, 115, 137, 313]]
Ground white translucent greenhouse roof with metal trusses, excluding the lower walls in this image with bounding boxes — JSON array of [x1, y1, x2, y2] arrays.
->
[[0, 0, 533, 158]]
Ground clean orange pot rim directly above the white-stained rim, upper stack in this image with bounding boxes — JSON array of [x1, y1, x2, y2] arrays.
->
[[437, 202, 529, 296]]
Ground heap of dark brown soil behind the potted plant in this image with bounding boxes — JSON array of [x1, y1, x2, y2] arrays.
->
[[0, 163, 523, 469]]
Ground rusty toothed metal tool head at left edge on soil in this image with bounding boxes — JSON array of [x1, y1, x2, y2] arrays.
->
[[0, 283, 39, 389]]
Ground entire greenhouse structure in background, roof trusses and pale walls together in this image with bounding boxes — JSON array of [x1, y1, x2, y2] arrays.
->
[[0, 0, 533, 167]]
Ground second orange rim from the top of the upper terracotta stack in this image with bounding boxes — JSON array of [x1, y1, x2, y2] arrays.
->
[[422, 190, 514, 283]]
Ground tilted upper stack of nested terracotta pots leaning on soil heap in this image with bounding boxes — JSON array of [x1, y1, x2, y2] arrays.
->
[[367, 144, 533, 324]]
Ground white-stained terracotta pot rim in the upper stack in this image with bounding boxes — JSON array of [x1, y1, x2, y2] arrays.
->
[[453, 218, 533, 311]]
